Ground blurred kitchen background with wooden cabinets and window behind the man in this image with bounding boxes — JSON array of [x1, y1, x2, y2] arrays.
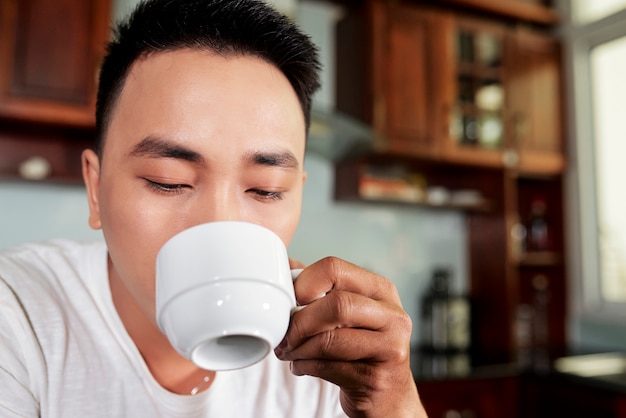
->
[[0, 0, 626, 418]]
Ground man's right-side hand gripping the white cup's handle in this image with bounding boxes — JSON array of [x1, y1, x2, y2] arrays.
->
[[275, 257, 426, 417]]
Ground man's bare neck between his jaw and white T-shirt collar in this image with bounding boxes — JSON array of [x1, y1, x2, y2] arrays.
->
[[109, 261, 215, 395]]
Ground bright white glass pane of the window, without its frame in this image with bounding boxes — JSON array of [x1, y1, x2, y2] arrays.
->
[[590, 37, 626, 302]]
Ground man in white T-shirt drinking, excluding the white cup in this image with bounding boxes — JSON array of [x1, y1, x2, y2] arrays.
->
[[0, 0, 425, 417]]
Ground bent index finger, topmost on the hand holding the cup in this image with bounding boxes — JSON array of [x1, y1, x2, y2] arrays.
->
[[295, 257, 400, 305]]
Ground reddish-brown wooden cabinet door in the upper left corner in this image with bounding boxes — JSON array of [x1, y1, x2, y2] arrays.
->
[[0, 0, 110, 127]]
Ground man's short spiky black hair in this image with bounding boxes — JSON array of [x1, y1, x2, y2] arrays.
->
[[96, 0, 321, 157]]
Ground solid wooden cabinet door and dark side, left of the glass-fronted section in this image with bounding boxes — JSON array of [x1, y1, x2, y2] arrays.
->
[[336, 1, 443, 157]]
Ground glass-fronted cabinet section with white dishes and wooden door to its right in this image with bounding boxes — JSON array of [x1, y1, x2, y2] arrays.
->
[[433, 13, 565, 174]]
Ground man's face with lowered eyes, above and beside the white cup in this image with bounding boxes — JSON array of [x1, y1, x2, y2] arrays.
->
[[83, 50, 305, 324]]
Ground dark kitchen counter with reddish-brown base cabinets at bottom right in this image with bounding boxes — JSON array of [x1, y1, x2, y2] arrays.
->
[[413, 353, 626, 418]]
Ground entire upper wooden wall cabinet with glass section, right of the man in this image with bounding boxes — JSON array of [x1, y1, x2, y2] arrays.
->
[[337, 0, 564, 174]]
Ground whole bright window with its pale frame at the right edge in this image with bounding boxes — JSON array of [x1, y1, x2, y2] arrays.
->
[[564, 0, 626, 325]]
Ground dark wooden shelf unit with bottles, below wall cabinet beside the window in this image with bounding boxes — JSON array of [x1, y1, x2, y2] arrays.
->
[[467, 170, 568, 364]]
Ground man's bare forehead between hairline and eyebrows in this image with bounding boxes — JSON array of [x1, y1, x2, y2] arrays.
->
[[105, 49, 305, 158]]
